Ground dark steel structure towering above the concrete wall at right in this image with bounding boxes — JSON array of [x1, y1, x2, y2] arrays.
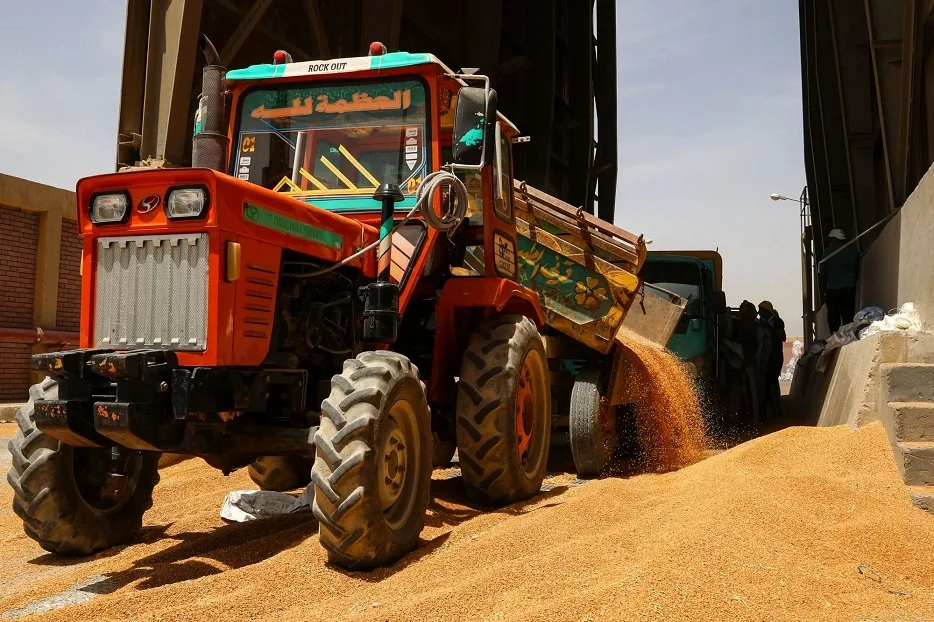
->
[[799, 0, 934, 342]]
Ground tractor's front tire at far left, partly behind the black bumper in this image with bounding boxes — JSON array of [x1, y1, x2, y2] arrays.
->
[[7, 378, 159, 555]]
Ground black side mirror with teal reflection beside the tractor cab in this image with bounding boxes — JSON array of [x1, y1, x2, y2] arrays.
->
[[452, 86, 496, 166]]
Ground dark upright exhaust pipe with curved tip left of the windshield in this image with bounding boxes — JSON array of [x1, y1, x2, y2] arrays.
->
[[191, 35, 230, 172]]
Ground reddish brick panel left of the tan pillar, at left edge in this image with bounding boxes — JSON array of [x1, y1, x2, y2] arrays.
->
[[0, 206, 39, 401]]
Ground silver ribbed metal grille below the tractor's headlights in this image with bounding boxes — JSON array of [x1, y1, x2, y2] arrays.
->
[[94, 233, 208, 351]]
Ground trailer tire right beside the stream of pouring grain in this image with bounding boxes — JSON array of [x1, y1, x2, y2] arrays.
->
[[570, 367, 617, 475]]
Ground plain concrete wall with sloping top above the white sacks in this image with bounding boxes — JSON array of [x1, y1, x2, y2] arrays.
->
[[860, 163, 934, 330]]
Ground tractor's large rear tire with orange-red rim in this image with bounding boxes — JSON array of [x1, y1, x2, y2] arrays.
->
[[457, 315, 551, 506]]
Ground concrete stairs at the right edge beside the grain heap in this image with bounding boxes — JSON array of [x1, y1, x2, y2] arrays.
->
[[880, 363, 934, 513]]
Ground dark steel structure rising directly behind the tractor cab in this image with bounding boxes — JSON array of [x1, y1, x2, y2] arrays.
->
[[117, 0, 617, 222]]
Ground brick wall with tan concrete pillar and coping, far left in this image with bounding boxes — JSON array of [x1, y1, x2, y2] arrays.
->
[[0, 174, 81, 402]]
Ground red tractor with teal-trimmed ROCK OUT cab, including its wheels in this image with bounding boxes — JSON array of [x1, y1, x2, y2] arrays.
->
[[8, 38, 552, 568]]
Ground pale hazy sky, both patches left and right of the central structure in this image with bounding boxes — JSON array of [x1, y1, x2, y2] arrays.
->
[[0, 0, 805, 335]]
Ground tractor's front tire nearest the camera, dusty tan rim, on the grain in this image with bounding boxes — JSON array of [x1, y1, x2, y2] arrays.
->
[[311, 351, 432, 570]]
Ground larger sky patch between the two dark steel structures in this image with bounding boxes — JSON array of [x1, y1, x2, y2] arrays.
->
[[616, 0, 806, 336]]
